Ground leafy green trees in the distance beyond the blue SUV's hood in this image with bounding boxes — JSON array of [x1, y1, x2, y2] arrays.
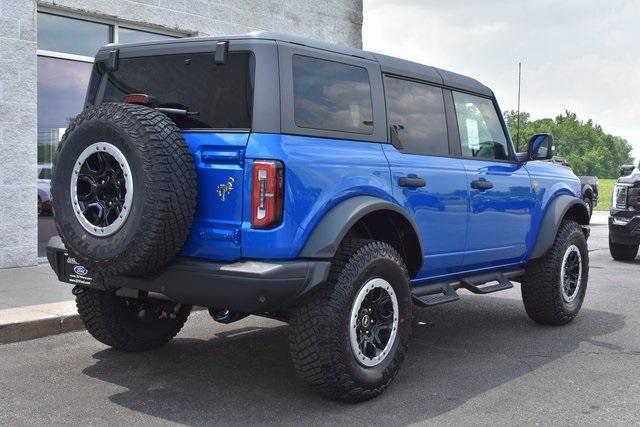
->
[[504, 110, 633, 178]]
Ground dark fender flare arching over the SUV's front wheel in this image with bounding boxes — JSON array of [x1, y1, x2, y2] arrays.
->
[[529, 194, 589, 259]]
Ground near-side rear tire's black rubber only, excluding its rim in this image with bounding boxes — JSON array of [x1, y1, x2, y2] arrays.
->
[[289, 239, 412, 402]]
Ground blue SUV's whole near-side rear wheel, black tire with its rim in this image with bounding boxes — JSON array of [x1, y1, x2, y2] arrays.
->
[[289, 239, 412, 402]]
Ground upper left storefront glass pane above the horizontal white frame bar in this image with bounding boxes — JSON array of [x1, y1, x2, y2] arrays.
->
[[38, 12, 112, 57]]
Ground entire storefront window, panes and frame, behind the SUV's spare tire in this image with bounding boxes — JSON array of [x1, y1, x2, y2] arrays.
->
[[37, 11, 182, 257]]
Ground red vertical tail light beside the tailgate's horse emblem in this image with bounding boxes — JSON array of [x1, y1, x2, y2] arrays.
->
[[251, 160, 284, 228]]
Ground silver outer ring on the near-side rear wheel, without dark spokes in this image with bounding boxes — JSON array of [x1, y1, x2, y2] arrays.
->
[[349, 278, 399, 368]]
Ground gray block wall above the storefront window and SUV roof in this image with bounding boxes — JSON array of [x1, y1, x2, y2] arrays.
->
[[40, 0, 362, 48]]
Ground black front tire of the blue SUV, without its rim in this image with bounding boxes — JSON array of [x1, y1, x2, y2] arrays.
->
[[521, 221, 589, 325]]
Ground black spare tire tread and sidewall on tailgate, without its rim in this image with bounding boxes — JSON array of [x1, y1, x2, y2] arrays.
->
[[51, 103, 197, 275]]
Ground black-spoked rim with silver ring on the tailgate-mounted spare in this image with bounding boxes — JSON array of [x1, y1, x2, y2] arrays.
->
[[71, 142, 133, 237]]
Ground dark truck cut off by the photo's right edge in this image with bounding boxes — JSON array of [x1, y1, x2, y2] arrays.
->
[[609, 163, 640, 261]]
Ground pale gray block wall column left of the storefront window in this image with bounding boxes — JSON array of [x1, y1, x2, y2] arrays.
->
[[0, 0, 38, 267]]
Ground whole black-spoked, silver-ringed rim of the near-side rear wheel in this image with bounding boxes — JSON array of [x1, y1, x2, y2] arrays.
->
[[349, 278, 399, 368]]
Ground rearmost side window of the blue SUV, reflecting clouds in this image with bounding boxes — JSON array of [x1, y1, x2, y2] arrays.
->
[[293, 55, 373, 135]]
